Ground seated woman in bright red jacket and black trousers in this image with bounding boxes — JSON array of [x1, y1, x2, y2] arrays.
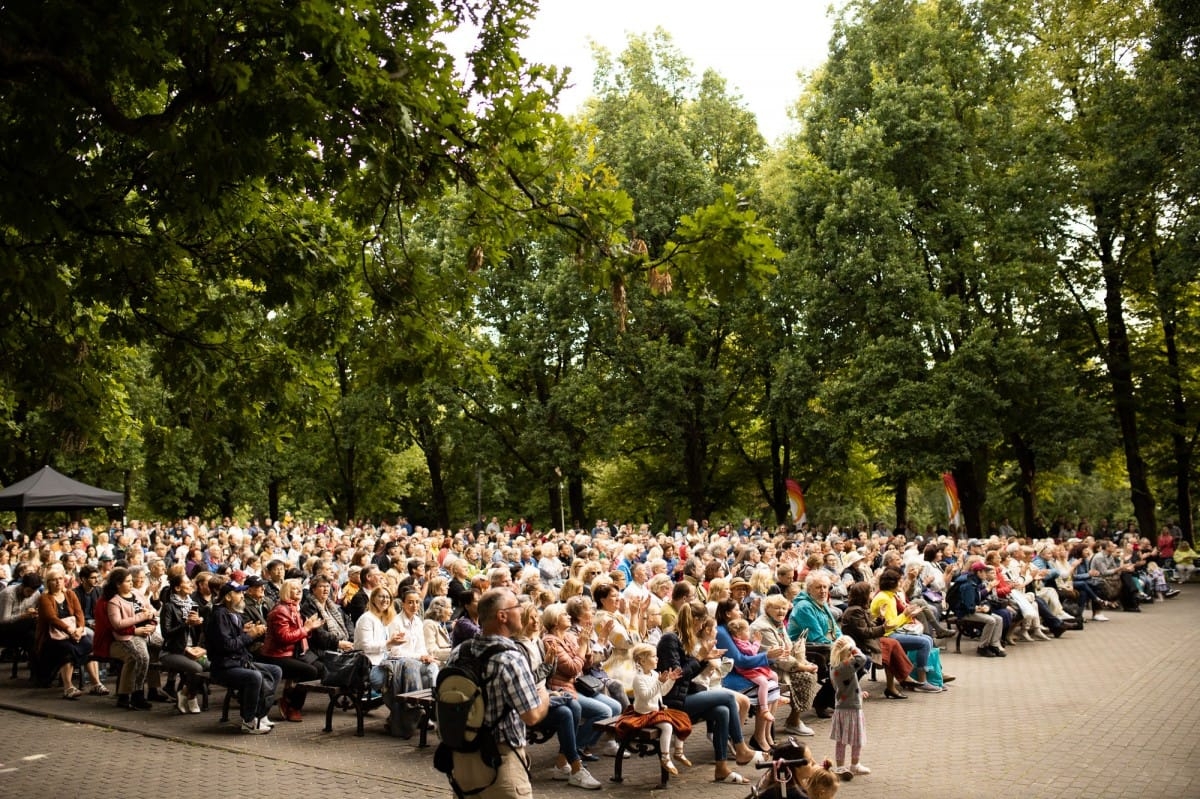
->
[[258, 579, 325, 721]]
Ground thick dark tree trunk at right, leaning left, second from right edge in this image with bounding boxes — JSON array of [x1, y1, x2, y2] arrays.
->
[[1093, 211, 1157, 536]]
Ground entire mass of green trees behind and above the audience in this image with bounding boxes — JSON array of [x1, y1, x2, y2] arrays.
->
[[0, 0, 1200, 535]]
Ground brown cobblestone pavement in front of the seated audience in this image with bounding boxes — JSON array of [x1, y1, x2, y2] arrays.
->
[[0, 583, 1200, 799]]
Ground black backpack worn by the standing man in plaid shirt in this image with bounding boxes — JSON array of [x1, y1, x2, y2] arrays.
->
[[433, 641, 516, 799]]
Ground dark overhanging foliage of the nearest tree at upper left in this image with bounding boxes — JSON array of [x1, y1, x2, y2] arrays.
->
[[0, 0, 560, 506]]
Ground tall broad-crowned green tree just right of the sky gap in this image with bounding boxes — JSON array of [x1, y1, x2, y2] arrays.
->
[[784, 0, 1080, 534]]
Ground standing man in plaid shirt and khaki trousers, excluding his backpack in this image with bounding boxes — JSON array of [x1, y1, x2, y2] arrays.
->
[[436, 588, 550, 799]]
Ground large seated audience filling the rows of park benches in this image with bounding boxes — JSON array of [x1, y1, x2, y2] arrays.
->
[[0, 517, 1195, 789]]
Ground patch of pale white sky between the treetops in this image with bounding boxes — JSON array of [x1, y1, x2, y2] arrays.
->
[[521, 0, 833, 142]]
